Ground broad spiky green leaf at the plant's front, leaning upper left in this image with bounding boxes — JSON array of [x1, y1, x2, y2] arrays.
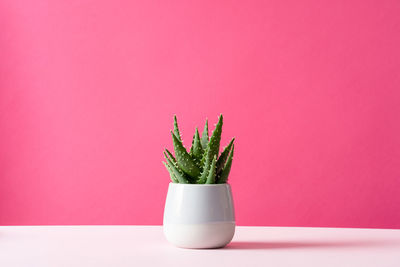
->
[[171, 132, 200, 178]]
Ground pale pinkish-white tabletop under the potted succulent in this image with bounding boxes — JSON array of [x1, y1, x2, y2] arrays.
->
[[0, 226, 400, 267]]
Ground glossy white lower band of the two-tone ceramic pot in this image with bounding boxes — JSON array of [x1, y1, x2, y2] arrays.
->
[[164, 222, 235, 248]]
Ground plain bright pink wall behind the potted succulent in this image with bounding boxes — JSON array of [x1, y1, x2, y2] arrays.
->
[[0, 0, 400, 228]]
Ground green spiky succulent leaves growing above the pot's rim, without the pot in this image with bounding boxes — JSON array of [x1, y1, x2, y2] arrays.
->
[[163, 114, 235, 184]]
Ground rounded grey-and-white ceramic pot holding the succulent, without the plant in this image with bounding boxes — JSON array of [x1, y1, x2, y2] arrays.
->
[[164, 183, 235, 248]]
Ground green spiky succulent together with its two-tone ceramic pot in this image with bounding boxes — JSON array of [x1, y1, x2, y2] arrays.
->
[[163, 115, 235, 248]]
